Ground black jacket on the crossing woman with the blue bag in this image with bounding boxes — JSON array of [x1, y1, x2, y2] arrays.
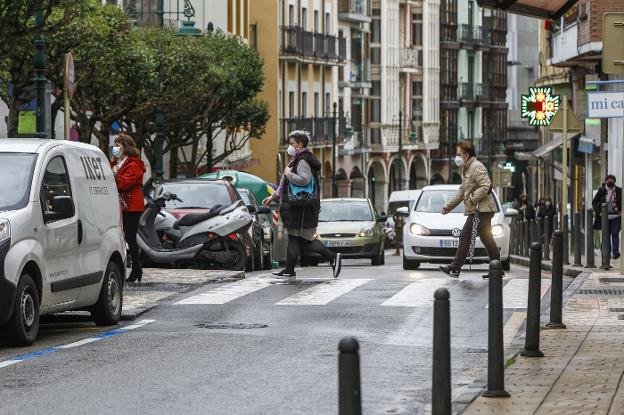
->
[[280, 151, 321, 229]]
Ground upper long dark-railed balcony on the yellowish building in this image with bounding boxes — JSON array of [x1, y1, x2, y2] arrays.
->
[[281, 26, 346, 63]]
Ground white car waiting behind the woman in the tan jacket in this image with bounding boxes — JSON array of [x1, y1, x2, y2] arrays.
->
[[400, 185, 518, 271]]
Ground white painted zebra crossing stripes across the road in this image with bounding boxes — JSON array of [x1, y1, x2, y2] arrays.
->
[[174, 275, 550, 309]]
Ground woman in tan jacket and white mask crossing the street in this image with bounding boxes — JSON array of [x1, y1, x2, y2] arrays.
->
[[439, 141, 500, 278]]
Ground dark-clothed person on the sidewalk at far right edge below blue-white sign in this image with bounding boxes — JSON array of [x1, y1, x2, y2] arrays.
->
[[592, 174, 622, 259]]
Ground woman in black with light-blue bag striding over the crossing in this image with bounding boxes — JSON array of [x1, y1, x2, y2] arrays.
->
[[262, 130, 342, 280]]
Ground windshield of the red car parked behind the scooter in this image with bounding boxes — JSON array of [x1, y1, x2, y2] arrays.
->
[[162, 182, 232, 209]]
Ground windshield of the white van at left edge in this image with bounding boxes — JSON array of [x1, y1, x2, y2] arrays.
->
[[0, 153, 37, 211]]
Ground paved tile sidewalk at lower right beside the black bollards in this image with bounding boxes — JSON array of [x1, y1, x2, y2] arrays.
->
[[463, 271, 624, 415]]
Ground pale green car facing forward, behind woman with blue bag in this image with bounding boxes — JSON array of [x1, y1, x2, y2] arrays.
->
[[312, 198, 387, 265]]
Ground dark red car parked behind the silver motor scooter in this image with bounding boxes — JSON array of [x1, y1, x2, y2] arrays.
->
[[146, 179, 255, 271]]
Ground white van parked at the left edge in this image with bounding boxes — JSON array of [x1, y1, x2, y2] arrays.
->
[[0, 139, 126, 345]]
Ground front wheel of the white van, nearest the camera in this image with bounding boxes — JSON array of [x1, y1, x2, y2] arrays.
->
[[2, 274, 39, 346]]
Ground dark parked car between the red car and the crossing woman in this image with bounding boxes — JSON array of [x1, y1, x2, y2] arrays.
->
[[238, 188, 273, 270]]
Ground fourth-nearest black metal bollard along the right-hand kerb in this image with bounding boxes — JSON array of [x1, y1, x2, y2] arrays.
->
[[520, 242, 544, 357]]
